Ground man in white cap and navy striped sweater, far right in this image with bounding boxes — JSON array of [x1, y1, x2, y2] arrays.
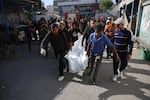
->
[[113, 17, 133, 81]]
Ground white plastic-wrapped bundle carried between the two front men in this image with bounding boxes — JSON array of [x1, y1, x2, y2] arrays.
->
[[65, 36, 88, 73]]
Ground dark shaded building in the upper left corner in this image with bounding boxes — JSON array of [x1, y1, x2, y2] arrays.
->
[[0, 0, 38, 27]]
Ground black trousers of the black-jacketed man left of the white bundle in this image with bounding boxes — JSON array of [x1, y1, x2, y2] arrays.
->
[[57, 51, 67, 76]]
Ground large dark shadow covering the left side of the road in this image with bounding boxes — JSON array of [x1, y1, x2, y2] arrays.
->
[[0, 43, 78, 100]]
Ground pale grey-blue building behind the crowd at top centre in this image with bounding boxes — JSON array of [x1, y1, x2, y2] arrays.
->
[[54, 0, 100, 16]]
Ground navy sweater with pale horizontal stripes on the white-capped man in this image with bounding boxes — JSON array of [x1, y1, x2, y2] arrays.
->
[[113, 29, 133, 54]]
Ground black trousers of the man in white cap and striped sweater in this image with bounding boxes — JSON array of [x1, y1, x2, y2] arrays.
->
[[113, 52, 128, 75]]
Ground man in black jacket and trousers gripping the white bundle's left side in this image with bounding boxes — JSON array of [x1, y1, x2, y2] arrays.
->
[[41, 23, 69, 81]]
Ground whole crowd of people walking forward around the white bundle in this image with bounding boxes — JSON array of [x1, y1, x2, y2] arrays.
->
[[39, 17, 133, 84]]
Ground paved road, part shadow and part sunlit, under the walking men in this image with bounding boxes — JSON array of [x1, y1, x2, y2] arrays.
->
[[0, 43, 150, 100]]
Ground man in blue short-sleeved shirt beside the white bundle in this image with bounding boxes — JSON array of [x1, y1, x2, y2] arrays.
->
[[84, 25, 120, 84]]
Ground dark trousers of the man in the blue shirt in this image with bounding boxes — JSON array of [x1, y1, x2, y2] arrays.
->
[[86, 55, 102, 82]]
